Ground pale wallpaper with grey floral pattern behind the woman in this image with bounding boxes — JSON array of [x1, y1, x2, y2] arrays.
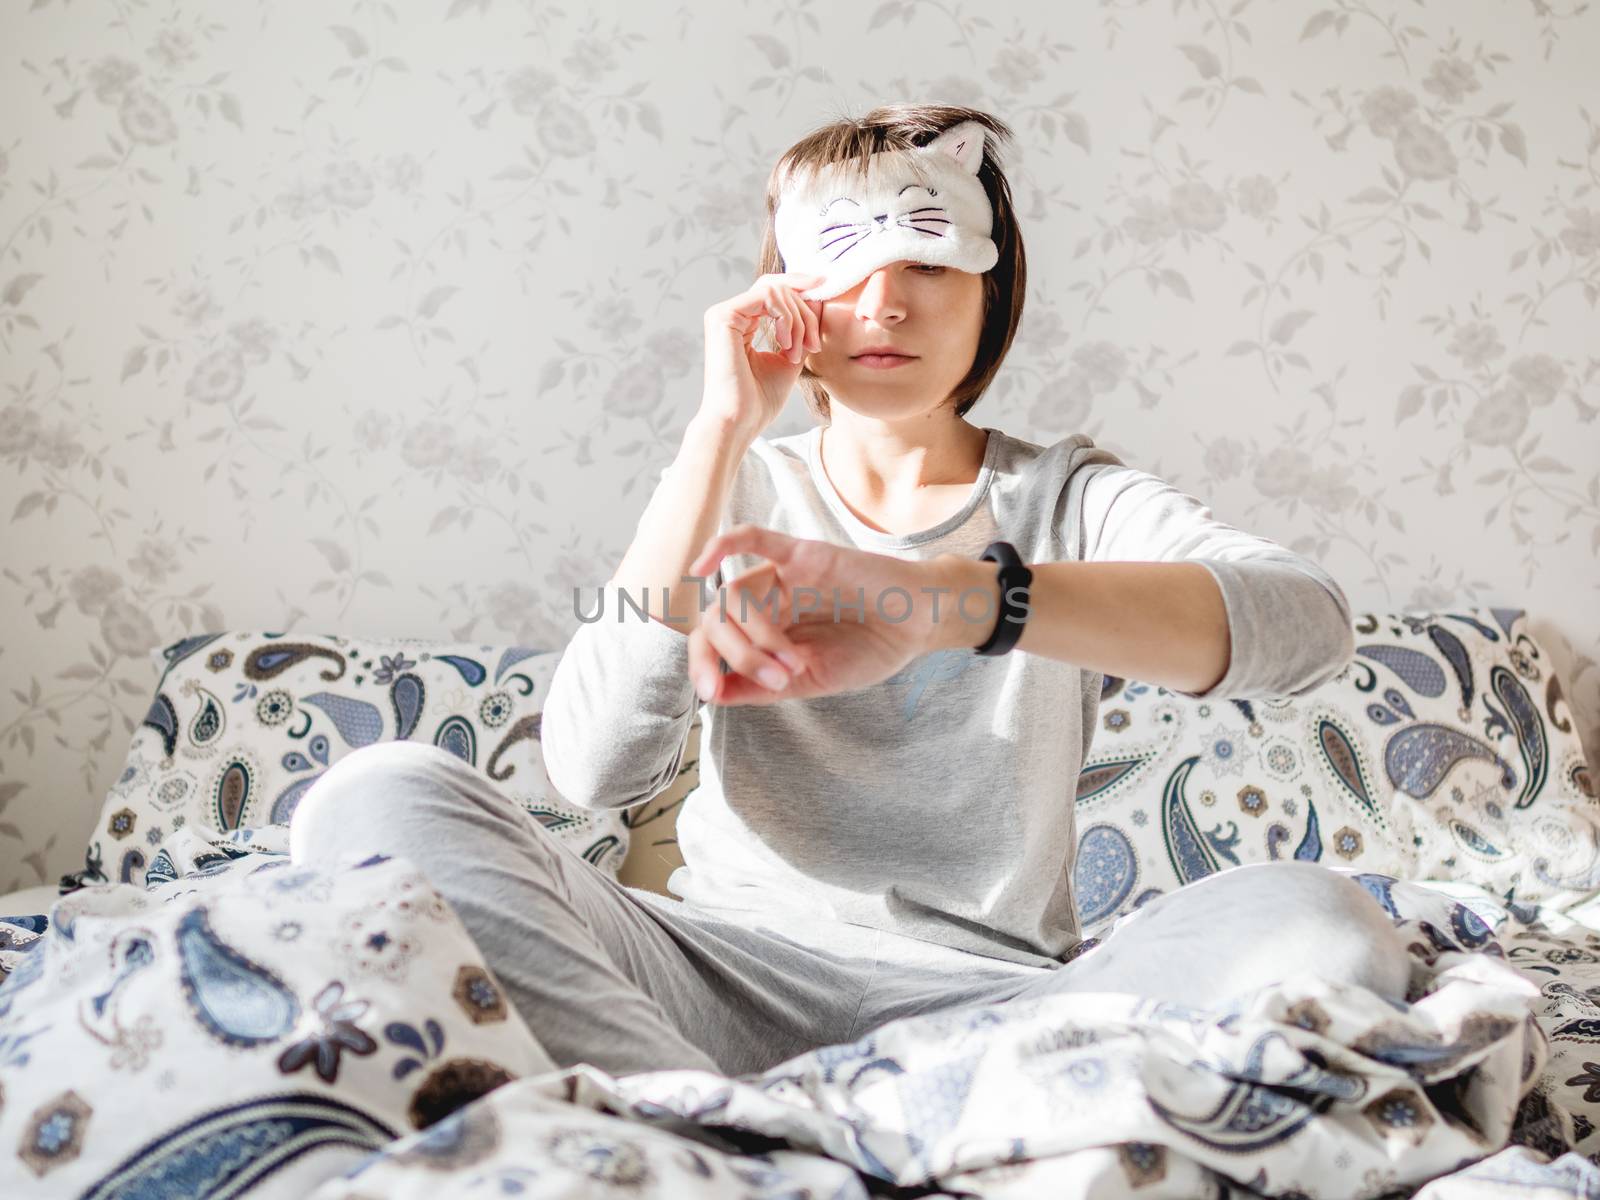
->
[[0, 0, 1600, 888]]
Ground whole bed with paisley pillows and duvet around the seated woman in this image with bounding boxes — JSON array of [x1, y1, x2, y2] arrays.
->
[[0, 608, 1600, 1200]]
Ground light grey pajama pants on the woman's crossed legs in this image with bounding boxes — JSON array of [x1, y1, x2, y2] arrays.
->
[[290, 741, 1410, 1075]]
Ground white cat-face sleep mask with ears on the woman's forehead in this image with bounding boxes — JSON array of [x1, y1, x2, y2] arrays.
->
[[773, 120, 1000, 299]]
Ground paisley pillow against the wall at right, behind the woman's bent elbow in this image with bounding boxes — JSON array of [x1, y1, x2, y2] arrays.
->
[[1074, 608, 1600, 936]]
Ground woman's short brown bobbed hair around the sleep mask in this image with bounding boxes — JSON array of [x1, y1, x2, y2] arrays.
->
[[757, 104, 1027, 421]]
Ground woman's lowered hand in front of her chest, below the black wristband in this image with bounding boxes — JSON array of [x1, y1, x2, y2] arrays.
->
[[688, 525, 979, 704]]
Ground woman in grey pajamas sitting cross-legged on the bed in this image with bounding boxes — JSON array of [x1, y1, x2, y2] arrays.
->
[[291, 106, 1408, 1074]]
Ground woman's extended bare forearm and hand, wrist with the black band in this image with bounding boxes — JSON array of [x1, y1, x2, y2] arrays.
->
[[675, 523, 1355, 704]]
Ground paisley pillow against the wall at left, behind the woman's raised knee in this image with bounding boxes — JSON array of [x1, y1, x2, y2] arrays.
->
[[61, 632, 629, 891]]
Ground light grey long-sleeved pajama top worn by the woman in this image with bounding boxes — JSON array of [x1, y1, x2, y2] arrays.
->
[[541, 427, 1354, 965]]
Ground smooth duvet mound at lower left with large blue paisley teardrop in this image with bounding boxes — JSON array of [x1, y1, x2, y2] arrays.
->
[[0, 853, 555, 1200]]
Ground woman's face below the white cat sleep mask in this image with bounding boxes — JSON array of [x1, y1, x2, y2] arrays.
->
[[805, 259, 984, 419]]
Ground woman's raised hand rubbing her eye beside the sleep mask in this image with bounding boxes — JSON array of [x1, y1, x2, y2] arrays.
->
[[701, 272, 822, 438]]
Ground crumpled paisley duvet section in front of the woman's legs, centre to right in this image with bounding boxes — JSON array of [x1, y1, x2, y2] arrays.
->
[[315, 875, 1547, 1200]]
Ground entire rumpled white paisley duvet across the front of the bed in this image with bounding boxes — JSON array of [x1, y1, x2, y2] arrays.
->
[[9, 851, 1600, 1200]]
